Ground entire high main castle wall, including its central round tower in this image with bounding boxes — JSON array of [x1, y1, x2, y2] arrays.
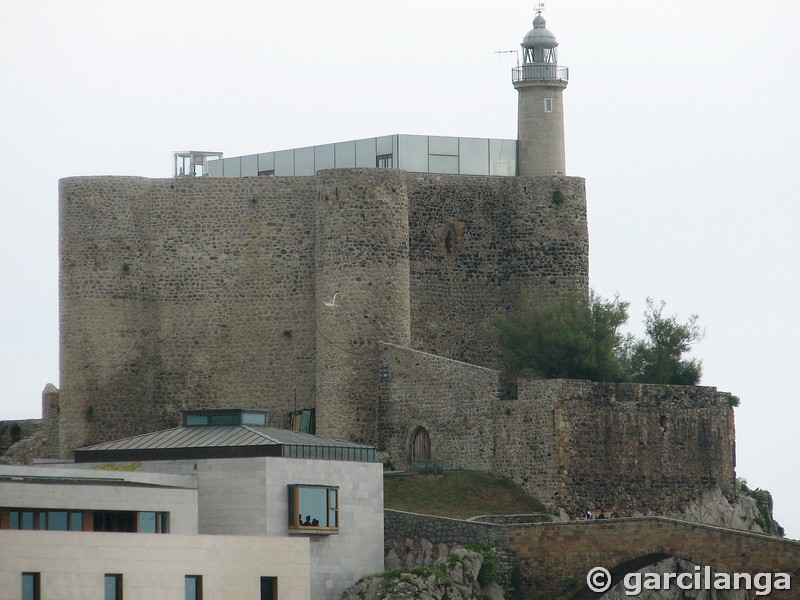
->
[[51, 169, 588, 455]]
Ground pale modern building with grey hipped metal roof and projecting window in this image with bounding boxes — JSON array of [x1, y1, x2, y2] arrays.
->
[[0, 410, 383, 600]]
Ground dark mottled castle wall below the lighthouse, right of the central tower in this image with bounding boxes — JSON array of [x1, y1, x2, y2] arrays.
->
[[408, 174, 589, 368]]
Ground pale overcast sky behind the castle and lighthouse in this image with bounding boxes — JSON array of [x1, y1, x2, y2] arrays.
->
[[0, 0, 800, 538]]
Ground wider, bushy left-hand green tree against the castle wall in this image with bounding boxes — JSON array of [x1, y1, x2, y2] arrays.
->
[[495, 292, 628, 381]]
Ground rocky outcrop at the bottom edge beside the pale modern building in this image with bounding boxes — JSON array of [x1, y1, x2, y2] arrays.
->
[[342, 543, 505, 600]]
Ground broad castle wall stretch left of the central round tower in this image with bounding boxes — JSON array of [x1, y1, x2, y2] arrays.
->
[[60, 177, 316, 454]]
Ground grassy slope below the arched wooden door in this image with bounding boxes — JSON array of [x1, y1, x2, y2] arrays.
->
[[383, 471, 547, 519]]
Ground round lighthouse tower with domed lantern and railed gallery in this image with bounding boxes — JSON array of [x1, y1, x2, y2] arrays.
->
[[512, 10, 569, 176]]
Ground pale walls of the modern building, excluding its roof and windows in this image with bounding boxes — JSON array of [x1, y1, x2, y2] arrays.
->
[[0, 457, 383, 600]]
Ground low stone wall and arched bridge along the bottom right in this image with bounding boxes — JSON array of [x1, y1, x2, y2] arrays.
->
[[384, 510, 800, 600]]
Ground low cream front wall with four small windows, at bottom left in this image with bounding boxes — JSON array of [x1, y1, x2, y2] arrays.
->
[[0, 530, 311, 600]]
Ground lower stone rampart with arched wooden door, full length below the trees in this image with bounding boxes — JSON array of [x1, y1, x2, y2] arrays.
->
[[378, 344, 735, 514]]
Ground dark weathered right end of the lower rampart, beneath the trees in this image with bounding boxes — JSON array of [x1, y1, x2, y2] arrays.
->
[[554, 381, 735, 514]]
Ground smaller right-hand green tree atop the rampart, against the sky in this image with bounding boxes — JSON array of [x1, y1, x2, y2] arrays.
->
[[624, 298, 705, 385]]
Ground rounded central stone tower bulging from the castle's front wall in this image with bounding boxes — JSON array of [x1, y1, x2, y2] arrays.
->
[[315, 169, 411, 444]]
